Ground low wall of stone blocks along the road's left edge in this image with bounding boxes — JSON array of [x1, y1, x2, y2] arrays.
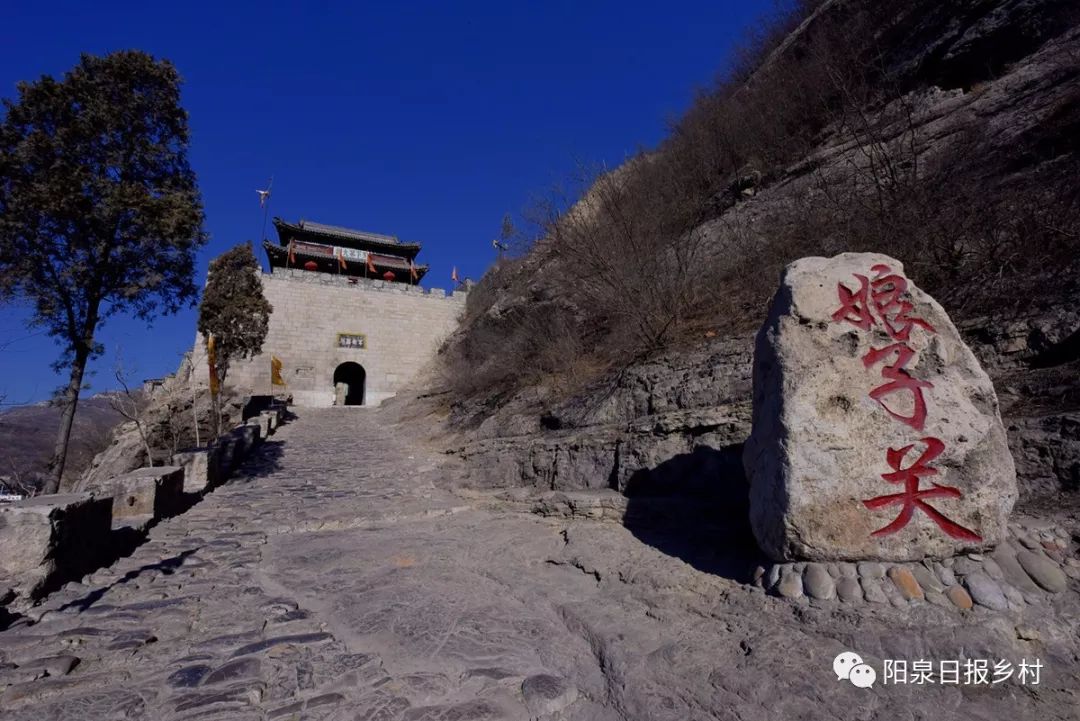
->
[[0, 407, 284, 618]]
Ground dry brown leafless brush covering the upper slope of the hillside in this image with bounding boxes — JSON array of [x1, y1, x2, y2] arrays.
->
[[442, 0, 1080, 403]]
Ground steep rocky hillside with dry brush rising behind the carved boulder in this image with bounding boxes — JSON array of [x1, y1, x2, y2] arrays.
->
[[410, 0, 1080, 511]]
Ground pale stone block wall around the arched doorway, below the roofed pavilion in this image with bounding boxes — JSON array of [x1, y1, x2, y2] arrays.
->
[[193, 268, 465, 406]]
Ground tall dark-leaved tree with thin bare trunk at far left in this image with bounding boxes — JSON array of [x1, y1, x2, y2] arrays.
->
[[0, 51, 206, 493]]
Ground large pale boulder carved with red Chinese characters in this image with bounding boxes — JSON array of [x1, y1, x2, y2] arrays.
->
[[743, 253, 1016, 561]]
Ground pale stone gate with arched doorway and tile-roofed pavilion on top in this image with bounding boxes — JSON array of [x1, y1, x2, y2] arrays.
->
[[194, 218, 465, 406]]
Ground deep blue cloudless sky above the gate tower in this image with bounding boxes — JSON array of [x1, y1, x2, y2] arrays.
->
[[0, 0, 772, 404]]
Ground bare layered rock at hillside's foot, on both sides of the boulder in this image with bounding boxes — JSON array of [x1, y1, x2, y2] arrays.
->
[[444, 312, 1080, 505]]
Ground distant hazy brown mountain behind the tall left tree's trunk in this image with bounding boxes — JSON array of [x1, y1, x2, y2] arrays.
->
[[0, 393, 124, 496]]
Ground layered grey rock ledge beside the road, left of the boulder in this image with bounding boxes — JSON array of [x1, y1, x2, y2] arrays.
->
[[457, 339, 752, 494]]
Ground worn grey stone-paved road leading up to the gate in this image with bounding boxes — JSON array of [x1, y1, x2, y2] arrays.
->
[[0, 409, 1080, 721]]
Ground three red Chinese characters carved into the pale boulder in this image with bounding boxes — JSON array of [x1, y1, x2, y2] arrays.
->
[[833, 263, 982, 542]]
